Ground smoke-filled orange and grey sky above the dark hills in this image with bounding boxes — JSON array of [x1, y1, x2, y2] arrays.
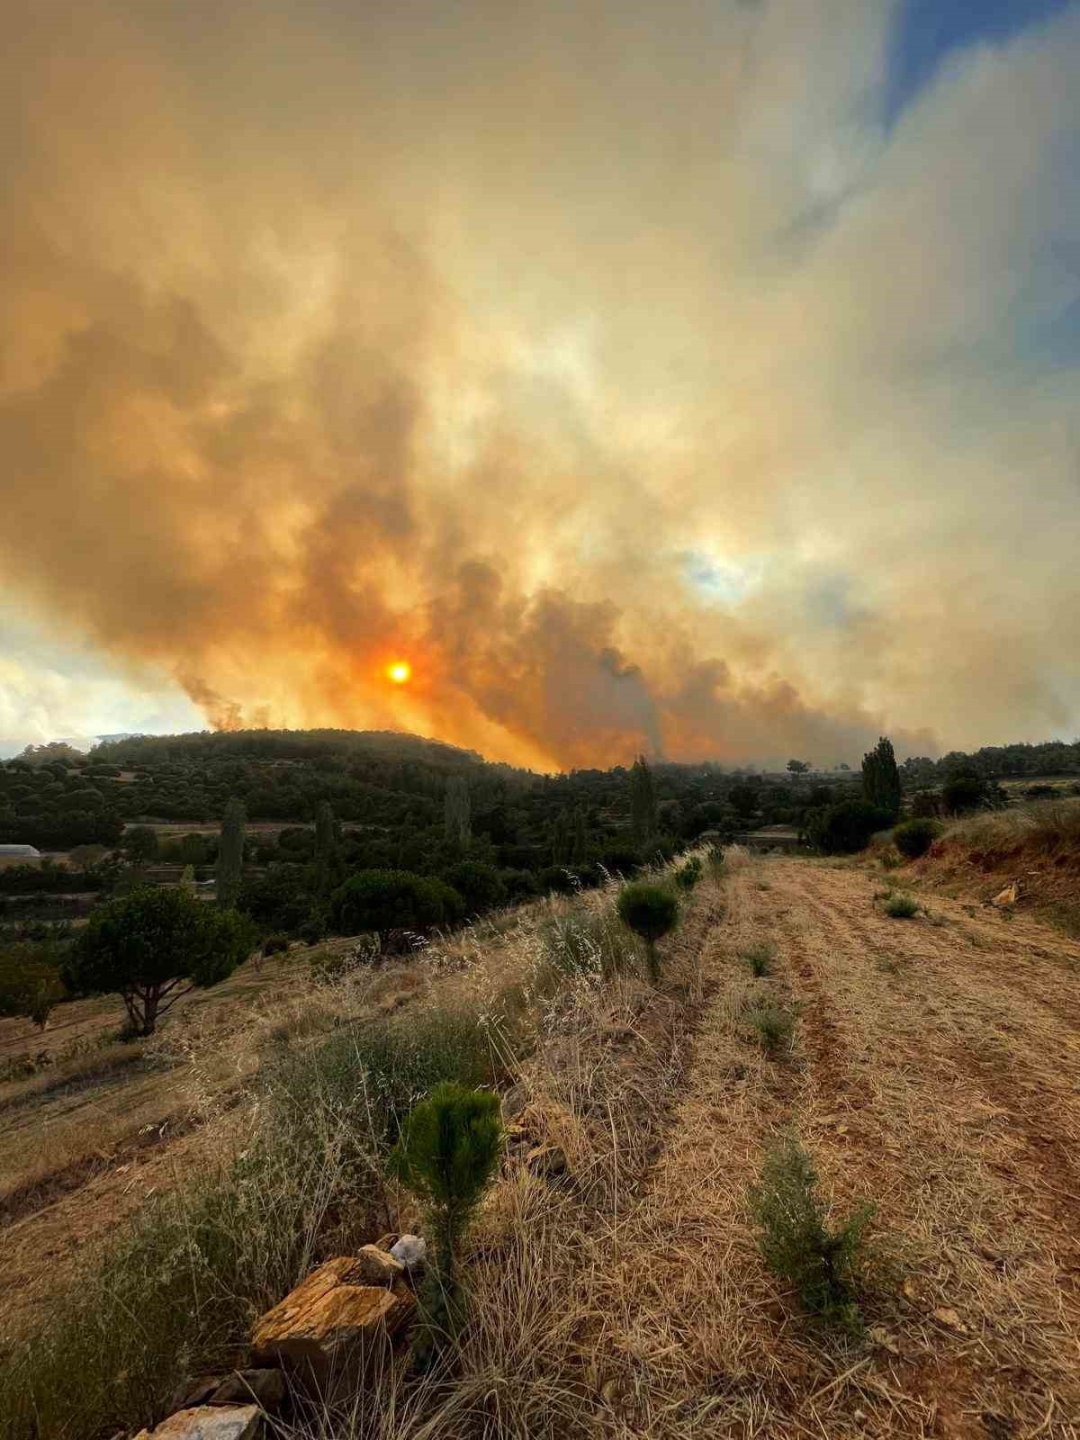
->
[[0, 0, 1080, 769]]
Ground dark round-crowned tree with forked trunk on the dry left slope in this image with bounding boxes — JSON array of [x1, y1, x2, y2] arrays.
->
[[63, 886, 252, 1035]]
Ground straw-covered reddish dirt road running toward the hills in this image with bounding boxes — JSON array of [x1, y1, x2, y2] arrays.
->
[[596, 860, 1080, 1440]]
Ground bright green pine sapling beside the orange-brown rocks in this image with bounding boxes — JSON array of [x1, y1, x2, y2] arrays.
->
[[390, 1083, 503, 1359]]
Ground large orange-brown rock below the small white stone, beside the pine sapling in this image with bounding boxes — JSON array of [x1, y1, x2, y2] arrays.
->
[[252, 1256, 416, 1392]]
